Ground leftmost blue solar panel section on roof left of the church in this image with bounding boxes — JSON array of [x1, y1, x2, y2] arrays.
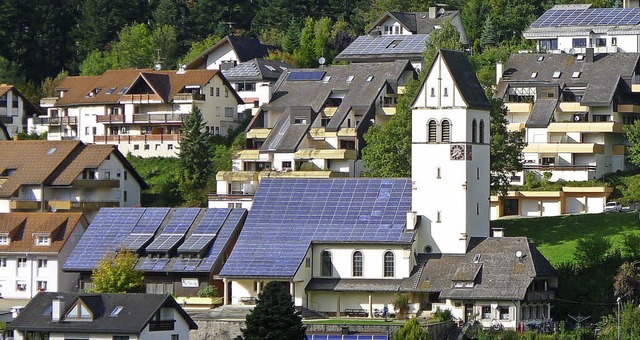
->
[[63, 208, 144, 271]]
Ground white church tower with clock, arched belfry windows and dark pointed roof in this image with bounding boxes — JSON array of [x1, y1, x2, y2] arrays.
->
[[411, 50, 491, 254]]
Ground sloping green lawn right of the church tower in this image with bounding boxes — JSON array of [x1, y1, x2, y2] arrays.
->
[[491, 212, 640, 265]]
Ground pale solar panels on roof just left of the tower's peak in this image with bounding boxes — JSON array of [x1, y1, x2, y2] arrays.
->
[[340, 34, 429, 56]]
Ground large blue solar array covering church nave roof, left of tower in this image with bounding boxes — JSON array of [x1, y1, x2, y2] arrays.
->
[[220, 178, 413, 277]]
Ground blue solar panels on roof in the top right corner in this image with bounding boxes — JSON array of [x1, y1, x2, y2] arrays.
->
[[531, 7, 640, 28]]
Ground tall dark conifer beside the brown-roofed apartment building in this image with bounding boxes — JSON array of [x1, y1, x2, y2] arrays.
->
[[178, 106, 212, 205]]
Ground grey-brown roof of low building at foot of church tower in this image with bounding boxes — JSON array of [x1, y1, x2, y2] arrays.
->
[[418, 237, 558, 300]]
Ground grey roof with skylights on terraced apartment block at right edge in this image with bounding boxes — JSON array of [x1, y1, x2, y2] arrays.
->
[[496, 53, 640, 106]]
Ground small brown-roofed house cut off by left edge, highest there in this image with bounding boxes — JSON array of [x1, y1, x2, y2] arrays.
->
[[0, 84, 39, 139]]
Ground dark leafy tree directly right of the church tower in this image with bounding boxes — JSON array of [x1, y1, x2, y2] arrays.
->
[[489, 99, 525, 196]]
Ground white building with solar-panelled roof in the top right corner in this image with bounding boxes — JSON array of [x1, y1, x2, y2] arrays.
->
[[522, 1, 640, 54]]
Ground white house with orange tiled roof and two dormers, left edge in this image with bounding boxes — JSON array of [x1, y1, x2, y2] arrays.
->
[[0, 212, 88, 299]]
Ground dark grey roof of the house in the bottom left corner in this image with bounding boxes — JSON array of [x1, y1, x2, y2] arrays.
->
[[8, 292, 198, 335]]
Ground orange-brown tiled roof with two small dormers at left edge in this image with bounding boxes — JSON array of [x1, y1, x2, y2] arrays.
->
[[0, 212, 87, 253]]
